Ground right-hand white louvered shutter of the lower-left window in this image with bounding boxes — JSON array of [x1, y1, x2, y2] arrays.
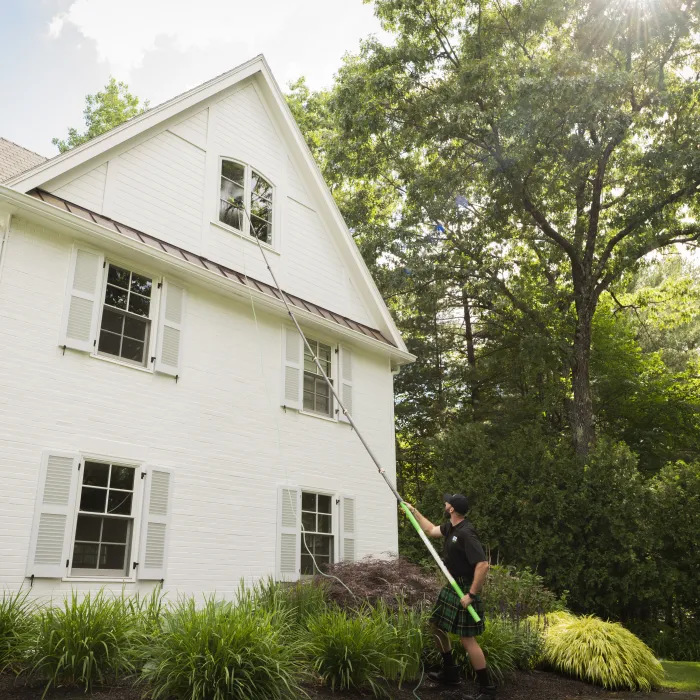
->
[[137, 467, 174, 580]]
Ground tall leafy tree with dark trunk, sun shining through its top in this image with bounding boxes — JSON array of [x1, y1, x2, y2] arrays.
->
[[330, 0, 700, 456]]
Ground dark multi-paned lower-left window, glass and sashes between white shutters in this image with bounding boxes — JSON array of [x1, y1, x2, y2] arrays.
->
[[71, 461, 136, 577]]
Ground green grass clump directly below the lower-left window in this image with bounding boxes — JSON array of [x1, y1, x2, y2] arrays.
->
[[28, 591, 142, 694]]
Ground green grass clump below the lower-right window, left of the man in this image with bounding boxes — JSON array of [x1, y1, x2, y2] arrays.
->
[[307, 608, 401, 697]]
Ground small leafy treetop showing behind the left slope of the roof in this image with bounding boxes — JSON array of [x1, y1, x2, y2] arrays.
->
[[51, 77, 148, 153]]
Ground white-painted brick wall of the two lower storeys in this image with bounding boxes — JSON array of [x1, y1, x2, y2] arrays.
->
[[0, 219, 397, 599]]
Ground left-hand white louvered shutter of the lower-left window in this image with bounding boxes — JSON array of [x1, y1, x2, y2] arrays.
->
[[27, 451, 80, 578]]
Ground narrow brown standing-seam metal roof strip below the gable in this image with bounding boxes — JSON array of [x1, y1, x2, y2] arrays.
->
[[27, 189, 396, 347]]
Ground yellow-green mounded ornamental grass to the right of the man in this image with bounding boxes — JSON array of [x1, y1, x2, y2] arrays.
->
[[544, 613, 664, 691]]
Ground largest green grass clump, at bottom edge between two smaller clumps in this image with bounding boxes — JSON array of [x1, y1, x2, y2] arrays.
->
[[142, 594, 304, 700]]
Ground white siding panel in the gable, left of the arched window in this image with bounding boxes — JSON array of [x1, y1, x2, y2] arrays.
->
[[109, 131, 205, 252]]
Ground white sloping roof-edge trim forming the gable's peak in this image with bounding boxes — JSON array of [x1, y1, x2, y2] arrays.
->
[[4, 55, 408, 353]]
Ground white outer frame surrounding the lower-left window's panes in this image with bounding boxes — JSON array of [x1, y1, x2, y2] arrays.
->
[[62, 452, 146, 583]]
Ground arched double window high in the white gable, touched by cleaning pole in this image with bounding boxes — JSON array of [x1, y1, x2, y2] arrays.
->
[[219, 159, 273, 245]]
